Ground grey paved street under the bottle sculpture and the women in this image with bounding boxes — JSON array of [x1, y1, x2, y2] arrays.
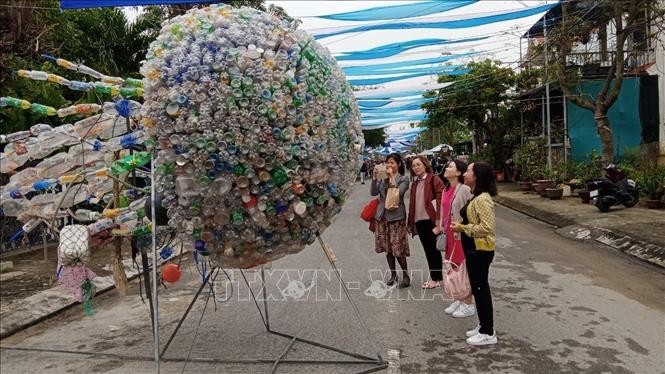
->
[[0, 184, 665, 374]]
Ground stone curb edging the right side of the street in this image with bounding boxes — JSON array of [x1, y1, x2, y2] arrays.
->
[[494, 196, 665, 269]]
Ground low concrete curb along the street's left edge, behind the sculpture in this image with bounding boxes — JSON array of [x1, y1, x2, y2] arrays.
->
[[0, 250, 189, 339]]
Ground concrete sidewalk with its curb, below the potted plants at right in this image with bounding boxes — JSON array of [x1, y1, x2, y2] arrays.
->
[[495, 183, 665, 268]]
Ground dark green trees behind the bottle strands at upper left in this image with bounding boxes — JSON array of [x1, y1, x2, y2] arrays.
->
[[0, 0, 282, 133]]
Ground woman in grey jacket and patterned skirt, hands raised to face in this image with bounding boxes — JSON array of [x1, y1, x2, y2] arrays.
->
[[370, 153, 411, 288]]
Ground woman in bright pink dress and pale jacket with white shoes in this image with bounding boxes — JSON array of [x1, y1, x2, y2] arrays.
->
[[434, 160, 476, 318]]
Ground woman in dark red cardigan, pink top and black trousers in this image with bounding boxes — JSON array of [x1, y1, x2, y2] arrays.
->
[[407, 156, 443, 288]]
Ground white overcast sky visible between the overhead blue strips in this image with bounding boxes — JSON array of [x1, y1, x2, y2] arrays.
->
[[125, 0, 558, 133]]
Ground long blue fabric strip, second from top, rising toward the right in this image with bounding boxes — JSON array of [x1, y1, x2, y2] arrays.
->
[[311, 4, 557, 39]]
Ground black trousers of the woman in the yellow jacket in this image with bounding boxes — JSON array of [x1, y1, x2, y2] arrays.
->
[[464, 251, 494, 335]]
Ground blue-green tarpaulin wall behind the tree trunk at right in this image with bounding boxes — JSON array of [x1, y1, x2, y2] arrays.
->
[[566, 78, 642, 162]]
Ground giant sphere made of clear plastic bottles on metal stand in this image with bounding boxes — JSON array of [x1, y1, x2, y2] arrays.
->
[[141, 5, 363, 268]]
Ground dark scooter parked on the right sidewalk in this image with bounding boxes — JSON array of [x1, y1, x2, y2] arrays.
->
[[587, 164, 640, 213]]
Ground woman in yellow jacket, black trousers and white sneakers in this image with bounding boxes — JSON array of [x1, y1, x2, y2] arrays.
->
[[452, 161, 497, 345]]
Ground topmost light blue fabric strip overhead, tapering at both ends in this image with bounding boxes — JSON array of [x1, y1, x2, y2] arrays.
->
[[319, 0, 476, 21]]
